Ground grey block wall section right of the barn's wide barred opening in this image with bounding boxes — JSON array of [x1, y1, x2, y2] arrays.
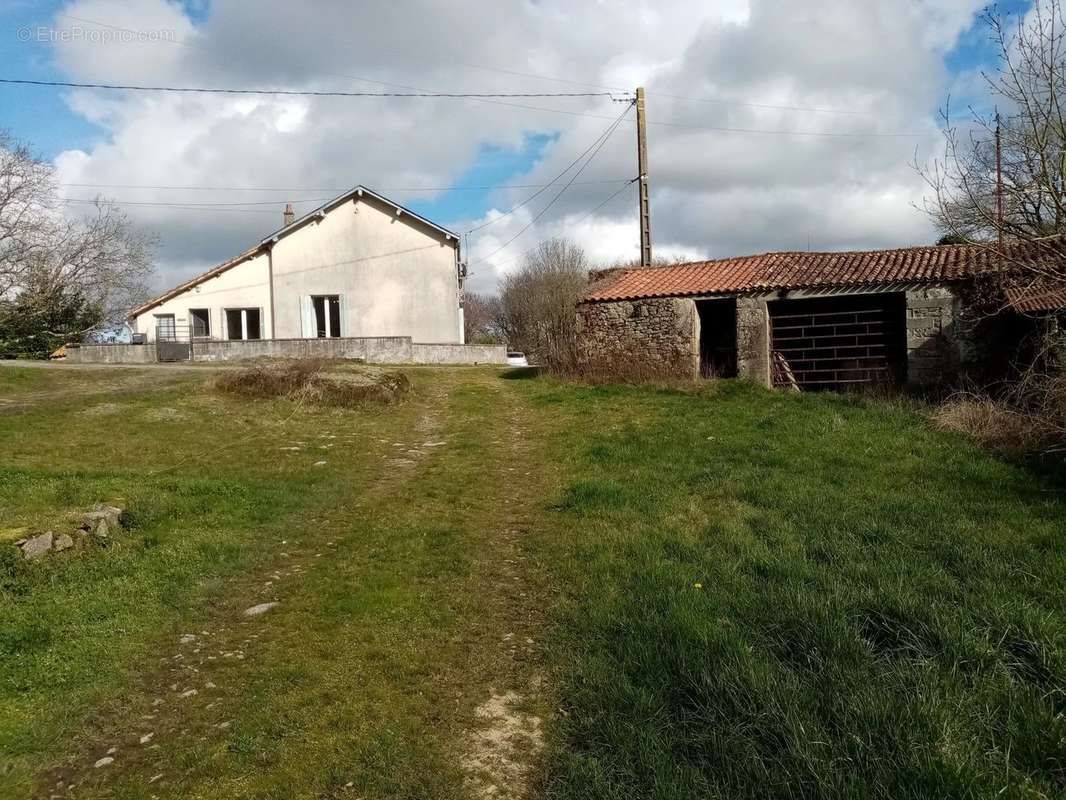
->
[[907, 286, 976, 388]]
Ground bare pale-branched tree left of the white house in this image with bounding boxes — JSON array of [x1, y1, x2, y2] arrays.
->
[[0, 132, 155, 333]]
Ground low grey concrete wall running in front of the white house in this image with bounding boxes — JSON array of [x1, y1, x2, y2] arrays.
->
[[67, 336, 507, 366]]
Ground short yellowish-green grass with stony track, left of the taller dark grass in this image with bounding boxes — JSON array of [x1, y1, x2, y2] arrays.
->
[[0, 370, 550, 798]]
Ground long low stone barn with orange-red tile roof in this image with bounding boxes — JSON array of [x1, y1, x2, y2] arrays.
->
[[578, 242, 1066, 390]]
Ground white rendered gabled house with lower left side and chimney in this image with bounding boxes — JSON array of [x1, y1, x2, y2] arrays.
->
[[129, 186, 463, 343]]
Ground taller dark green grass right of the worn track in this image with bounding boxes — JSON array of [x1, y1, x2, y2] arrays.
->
[[534, 385, 1066, 798]]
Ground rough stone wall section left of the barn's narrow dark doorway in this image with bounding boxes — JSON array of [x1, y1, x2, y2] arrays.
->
[[578, 298, 699, 378]]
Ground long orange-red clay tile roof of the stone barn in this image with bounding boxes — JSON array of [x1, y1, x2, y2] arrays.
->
[[583, 239, 1066, 302]]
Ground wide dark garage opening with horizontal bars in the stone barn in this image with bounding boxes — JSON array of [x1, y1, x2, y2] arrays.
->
[[769, 292, 906, 390]]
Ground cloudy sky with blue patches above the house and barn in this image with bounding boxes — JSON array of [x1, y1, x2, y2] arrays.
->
[[0, 0, 1028, 292]]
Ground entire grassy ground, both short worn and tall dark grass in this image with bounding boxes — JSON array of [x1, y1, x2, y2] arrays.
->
[[0, 367, 1066, 800]]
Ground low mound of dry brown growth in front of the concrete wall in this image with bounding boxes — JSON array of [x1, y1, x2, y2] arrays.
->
[[214, 359, 410, 407]]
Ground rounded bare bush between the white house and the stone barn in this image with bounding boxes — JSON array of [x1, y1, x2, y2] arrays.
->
[[500, 239, 588, 369]]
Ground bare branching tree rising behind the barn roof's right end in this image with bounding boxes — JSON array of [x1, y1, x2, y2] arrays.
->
[[917, 0, 1066, 283]]
